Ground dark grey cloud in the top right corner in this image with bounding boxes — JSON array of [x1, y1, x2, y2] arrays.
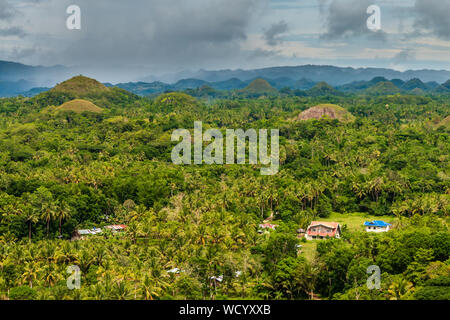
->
[[414, 0, 450, 40]]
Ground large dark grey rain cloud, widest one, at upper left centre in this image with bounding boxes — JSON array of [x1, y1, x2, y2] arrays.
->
[[51, 0, 264, 72]]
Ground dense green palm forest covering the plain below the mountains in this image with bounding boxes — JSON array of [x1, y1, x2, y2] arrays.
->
[[0, 77, 450, 299]]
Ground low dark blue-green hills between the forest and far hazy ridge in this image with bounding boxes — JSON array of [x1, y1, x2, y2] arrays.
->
[[0, 77, 450, 97]]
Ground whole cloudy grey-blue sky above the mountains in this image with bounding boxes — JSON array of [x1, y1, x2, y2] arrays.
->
[[0, 0, 450, 81]]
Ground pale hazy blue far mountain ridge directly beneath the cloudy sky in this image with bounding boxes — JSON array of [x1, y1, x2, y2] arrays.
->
[[0, 61, 450, 97]]
